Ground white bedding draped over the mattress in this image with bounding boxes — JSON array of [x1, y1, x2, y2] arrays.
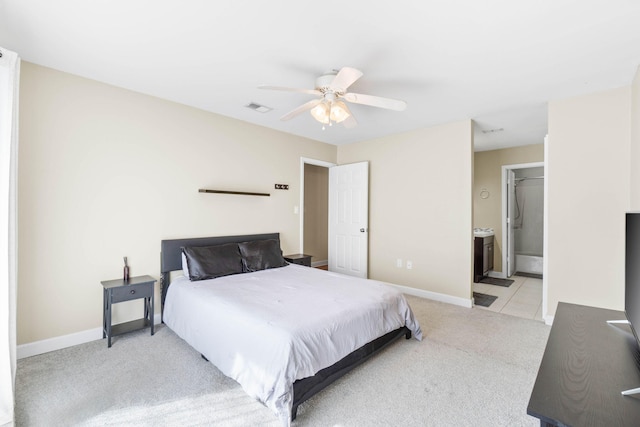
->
[[164, 264, 422, 425]]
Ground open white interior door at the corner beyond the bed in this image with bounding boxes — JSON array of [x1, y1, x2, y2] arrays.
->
[[329, 162, 369, 278]]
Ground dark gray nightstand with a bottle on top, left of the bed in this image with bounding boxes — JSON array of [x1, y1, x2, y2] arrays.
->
[[100, 276, 156, 347]]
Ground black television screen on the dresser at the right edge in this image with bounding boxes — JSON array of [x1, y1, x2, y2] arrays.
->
[[624, 212, 640, 344]]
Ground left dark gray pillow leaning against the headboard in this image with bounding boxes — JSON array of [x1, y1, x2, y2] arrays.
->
[[182, 243, 243, 281]]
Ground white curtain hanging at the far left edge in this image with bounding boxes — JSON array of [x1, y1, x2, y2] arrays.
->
[[0, 47, 20, 426]]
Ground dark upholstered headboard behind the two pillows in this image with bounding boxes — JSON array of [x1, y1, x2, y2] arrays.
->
[[160, 233, 280, 318]]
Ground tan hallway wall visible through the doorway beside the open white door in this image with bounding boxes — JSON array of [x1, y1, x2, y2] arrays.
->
[[304, 164, 329, 263]]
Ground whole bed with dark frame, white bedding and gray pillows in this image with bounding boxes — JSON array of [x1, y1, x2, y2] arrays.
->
[[161, 233, 422, 425]]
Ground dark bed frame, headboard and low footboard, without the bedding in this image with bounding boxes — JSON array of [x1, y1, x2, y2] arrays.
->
[[160, 233, 411, 421]]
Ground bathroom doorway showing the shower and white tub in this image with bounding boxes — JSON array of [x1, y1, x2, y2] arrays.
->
[[502, 162, 545, 278]]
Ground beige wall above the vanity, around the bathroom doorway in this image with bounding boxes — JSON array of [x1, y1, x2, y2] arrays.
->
[[473, 144, 544, 272]]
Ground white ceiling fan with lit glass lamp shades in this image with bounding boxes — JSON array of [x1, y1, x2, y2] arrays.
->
[[258, 67, 407, 129]]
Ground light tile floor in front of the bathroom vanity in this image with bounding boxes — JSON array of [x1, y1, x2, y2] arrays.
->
[[473, 275, 543, 322]]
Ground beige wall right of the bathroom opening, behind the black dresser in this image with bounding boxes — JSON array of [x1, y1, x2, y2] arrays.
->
[[543, 87, 639, 315]]
